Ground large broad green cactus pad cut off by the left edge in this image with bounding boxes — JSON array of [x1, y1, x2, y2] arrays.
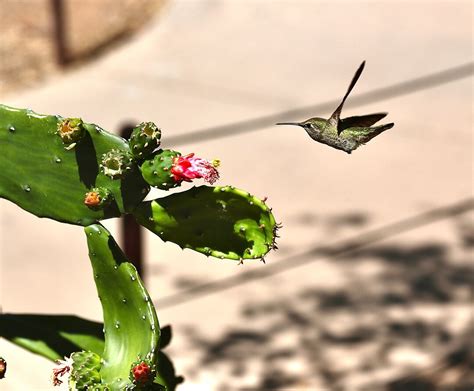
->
[[0, 105, 149, 225]]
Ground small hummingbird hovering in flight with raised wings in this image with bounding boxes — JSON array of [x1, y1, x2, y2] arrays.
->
[[276, 61, 394, 153]]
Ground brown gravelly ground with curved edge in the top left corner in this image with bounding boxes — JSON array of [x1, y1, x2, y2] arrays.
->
[[0, 0, 163, 95]]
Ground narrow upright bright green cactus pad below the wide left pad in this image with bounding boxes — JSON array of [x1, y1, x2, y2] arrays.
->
[[85, 224, 160, 390]]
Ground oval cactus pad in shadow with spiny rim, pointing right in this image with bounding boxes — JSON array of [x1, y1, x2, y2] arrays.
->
[[133, 186, 278, 260]]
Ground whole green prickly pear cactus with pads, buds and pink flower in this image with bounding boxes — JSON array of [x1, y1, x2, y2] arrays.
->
[[0, 105, 279, 391]]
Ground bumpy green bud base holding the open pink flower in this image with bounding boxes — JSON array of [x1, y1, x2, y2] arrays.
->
[[140, 149, 181, 190]]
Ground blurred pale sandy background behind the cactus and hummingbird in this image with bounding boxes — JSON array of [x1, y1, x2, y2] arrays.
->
[[0, 0, 474, 391]]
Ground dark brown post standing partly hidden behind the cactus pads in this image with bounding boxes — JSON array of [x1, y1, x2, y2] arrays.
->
[[120, 125, 145, 280]]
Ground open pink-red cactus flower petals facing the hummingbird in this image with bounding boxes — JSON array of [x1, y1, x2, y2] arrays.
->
[[171, 153, 219, 185]]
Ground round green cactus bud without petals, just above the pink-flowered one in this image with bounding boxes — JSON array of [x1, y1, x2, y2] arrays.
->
[[129, 122, 161, 161]]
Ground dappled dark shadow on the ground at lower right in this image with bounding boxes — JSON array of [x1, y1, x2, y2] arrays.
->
[[180, 214, 474, 391]]
